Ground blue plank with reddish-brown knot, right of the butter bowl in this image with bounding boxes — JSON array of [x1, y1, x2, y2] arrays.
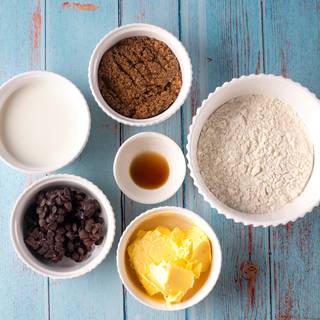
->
[[181, 0, 270, 320]]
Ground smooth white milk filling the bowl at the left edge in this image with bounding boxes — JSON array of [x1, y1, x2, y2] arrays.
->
[[0, 79, 87, 168]]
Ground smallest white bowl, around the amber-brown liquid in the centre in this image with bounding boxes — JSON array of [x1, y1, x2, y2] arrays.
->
[[113, 132, 186, 204]]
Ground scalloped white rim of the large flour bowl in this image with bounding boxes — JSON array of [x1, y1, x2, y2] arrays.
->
[[186, 73, 320, 227]]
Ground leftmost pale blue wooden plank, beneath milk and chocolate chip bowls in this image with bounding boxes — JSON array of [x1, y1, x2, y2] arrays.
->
[[0, 0, 48, 320]]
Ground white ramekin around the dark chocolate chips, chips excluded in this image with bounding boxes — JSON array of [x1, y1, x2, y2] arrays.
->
[[10, 174, 115, 279]]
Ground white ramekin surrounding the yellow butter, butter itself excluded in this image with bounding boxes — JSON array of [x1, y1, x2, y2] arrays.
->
[[117, 207, 222, 311]]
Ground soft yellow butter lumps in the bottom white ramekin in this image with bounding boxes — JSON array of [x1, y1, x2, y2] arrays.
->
[[127, 226, 212, 304]]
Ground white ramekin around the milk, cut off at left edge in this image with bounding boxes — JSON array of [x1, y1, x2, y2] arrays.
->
[[0, 71, 91, 174]]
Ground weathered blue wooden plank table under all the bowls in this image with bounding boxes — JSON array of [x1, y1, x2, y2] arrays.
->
[[0, 0, 320, 320]]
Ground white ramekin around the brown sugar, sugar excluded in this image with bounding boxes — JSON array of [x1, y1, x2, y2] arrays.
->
[[88, 23, 192, 126]]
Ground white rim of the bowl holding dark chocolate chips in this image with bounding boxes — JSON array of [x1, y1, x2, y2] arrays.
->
[[10, 174, 116, 279]]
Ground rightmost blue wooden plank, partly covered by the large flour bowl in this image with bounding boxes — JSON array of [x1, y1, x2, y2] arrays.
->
[[263, 0, 320, 320]]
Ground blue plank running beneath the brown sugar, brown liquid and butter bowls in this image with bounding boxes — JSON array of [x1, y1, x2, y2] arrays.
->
[[121, 0, 184, 320]]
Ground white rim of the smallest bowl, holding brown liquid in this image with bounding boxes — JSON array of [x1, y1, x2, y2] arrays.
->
[[113, 131, 187, 204]]
